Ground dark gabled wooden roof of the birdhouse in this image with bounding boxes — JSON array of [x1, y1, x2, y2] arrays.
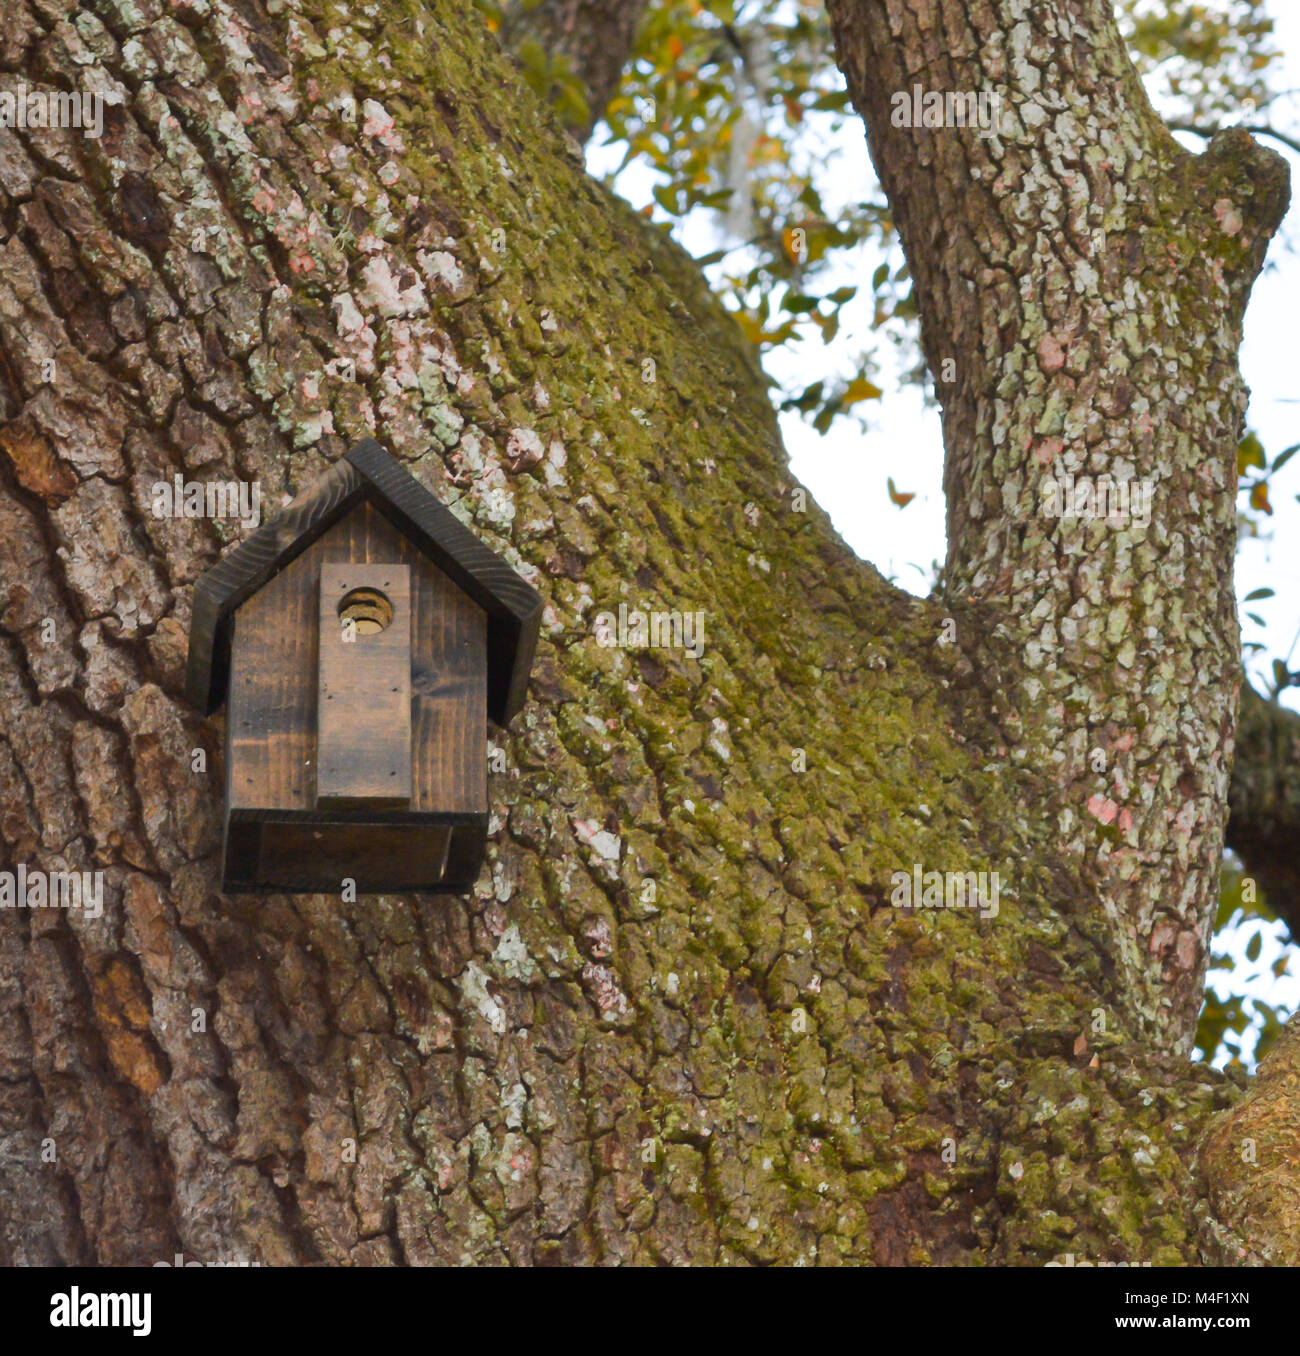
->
[[186, 438, 542, 725]]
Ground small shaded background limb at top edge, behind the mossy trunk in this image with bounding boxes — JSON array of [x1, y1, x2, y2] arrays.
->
[[500, 0, 649, 141]]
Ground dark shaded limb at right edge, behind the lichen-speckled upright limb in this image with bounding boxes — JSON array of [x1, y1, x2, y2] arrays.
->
[[1227, 682, 1300, 938]]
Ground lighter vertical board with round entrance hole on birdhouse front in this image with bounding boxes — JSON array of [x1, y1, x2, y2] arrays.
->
[[315, 561, 412, 810]]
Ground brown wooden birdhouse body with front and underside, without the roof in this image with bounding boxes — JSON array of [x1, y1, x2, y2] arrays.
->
[[225, 503, 487, 890]]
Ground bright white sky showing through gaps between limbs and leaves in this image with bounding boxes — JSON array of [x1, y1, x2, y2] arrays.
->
[[587, 0, 1300, 1055]]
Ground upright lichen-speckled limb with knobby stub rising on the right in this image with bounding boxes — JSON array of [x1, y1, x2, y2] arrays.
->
[[830, 0, 1289, 1050]]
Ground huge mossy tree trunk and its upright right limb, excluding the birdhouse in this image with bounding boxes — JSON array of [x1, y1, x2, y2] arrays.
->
[[0, 0, 1295, 1265]]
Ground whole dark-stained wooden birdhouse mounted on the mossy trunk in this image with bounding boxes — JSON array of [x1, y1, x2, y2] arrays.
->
[[187, 438, 542, 894]]
